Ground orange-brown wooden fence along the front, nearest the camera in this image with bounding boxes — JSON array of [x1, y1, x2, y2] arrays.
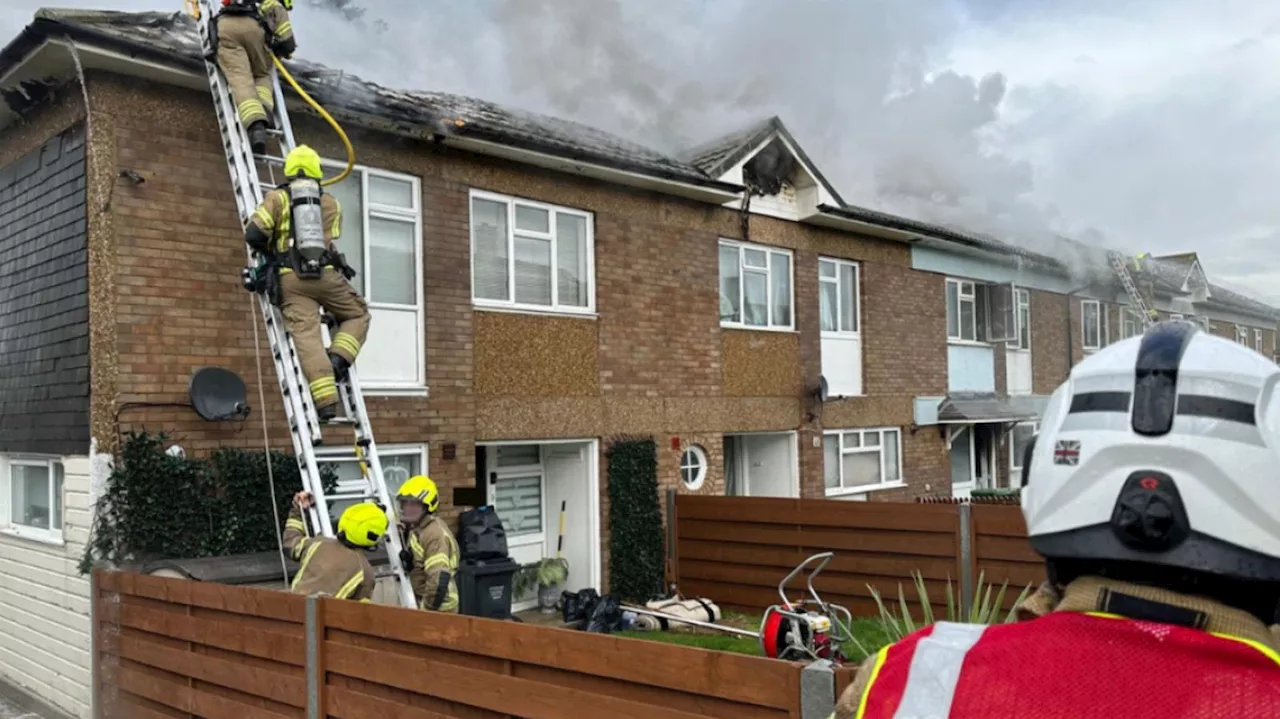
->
[[93, 569, 835, 719]]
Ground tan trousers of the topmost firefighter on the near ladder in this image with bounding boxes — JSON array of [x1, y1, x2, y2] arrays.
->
[[218, 15, 274, 128]]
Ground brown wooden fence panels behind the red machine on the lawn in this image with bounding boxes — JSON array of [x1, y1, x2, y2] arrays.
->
[[668, 495, 1043, 615]]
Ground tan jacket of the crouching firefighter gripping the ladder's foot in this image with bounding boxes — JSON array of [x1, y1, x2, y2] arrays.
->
[[284, 507, 378, 601]]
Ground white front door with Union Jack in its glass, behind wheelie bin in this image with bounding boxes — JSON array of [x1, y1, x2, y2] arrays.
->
[[488, 444, 547, 606]]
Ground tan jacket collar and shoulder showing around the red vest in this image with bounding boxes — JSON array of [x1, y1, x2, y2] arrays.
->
[[832, 577, 1280, 719]]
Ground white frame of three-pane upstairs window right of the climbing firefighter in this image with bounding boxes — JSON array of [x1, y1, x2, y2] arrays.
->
[[467, 187, 595, 317]]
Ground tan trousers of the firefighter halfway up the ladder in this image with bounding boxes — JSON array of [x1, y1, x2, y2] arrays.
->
[[280, 267, 369, 409]]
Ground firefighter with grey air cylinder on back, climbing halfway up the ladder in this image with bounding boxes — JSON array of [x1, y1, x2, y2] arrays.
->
[[244, 145, 370, 421]]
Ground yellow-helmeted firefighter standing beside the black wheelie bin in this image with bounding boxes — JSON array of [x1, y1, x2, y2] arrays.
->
[[396, 475, 460, 613]]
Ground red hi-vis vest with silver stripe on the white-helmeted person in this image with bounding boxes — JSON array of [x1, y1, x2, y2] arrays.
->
[[856, 612, 1280, 719]]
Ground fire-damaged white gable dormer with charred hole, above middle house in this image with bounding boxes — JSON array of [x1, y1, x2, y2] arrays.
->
[[684, 118, 845, 221]]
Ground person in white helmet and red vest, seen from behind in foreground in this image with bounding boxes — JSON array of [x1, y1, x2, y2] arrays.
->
[[835, 320, 1280, 719]]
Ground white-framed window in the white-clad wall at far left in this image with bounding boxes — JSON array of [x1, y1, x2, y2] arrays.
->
[[0, 455, 64, 544]]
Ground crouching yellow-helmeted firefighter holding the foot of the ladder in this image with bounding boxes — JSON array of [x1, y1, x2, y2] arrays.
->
[[284, 491, 389, 601]]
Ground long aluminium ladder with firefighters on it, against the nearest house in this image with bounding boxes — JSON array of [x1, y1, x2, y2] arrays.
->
[[196, 0, 416, 608]]
